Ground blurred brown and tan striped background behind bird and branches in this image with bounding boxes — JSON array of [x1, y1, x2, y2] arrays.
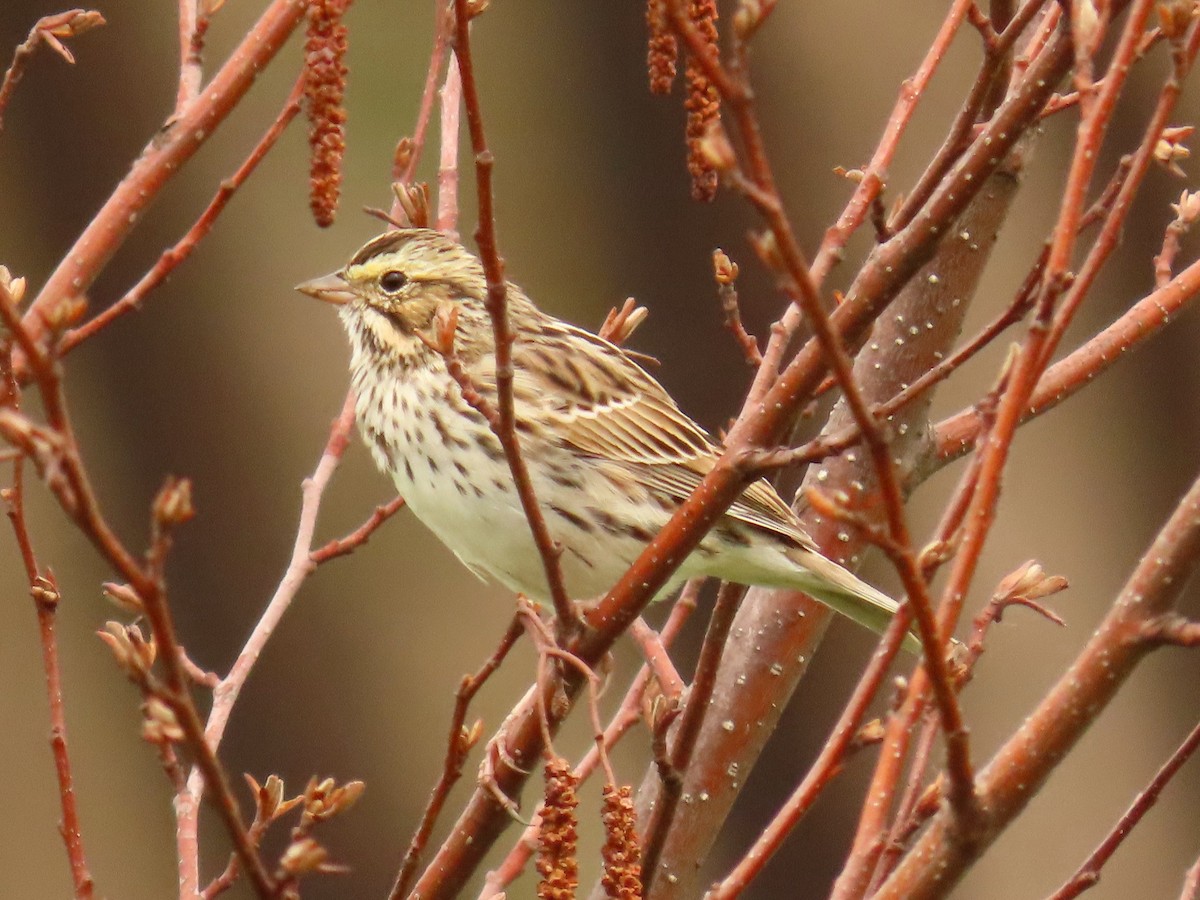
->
[[0, 0, 1200, 900]]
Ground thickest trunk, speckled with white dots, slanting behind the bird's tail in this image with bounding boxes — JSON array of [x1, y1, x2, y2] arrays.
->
[[643, 153, 1018, 898]]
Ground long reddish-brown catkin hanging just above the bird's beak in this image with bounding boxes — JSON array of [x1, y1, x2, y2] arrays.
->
[[305, 0, 350, 228]]
